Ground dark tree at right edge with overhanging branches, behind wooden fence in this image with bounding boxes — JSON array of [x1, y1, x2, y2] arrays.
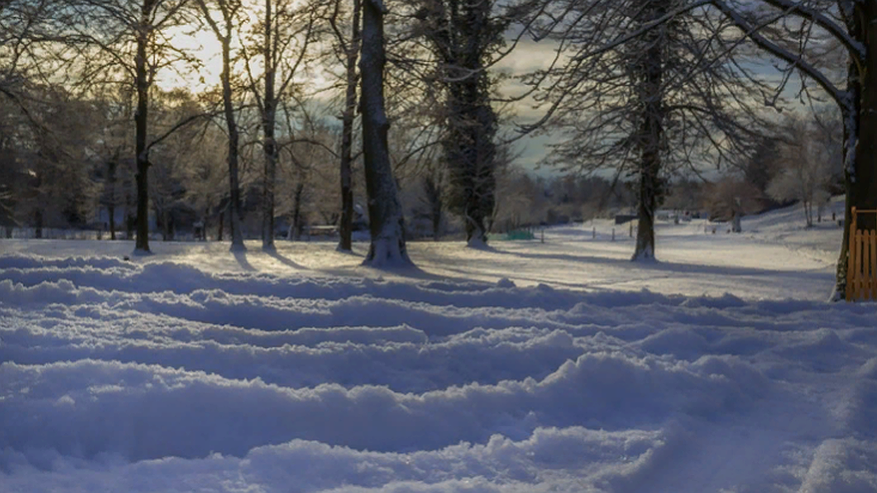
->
[[709, 0, 877, 300]]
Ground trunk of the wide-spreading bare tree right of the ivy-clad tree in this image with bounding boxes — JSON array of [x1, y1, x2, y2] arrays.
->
[[631, 2, 666, 261]]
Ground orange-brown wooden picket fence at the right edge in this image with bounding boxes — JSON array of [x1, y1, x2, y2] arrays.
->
[[846, 207, 877, 301]]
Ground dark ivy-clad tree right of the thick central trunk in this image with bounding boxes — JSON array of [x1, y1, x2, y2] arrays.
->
[[416, 0, 510, 246]]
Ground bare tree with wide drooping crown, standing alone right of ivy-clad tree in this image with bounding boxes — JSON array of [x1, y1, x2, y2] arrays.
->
[[526, 0, 764, 260]]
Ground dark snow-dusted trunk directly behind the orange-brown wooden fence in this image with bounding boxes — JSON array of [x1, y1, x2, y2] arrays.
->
[[831, 2, 877, 301]]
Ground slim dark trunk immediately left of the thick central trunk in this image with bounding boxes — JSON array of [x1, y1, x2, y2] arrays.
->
[[338, 0, 361, 252]]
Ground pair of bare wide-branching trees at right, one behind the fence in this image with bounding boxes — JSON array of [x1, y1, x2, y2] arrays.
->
[[512, 0, 877, 299]]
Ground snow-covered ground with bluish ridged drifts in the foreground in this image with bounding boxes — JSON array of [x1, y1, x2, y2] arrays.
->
[[0, 201, 877, 493]]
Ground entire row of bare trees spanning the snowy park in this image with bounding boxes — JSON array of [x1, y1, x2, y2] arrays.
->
[[0, 0, 877, 298]]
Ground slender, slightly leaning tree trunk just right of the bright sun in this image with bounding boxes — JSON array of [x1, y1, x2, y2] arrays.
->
[[222, 28, 247, 252]]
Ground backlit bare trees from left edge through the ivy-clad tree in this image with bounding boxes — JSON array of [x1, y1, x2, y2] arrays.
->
[[0, 0, 503, 265]]
